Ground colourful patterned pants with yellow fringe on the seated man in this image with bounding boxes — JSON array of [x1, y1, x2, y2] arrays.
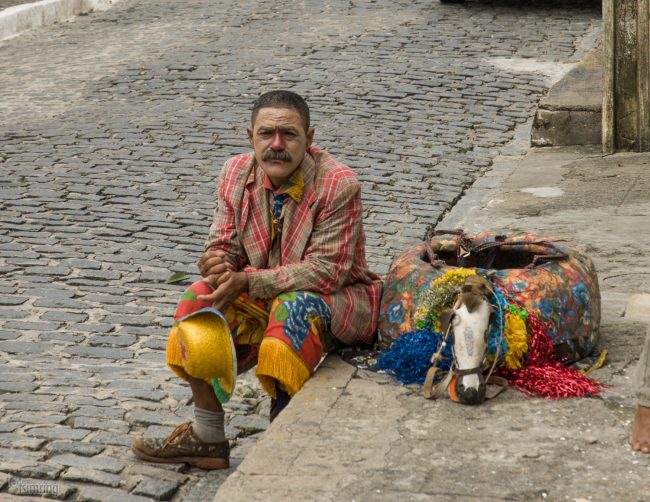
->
[[167, 281, 338, 398]]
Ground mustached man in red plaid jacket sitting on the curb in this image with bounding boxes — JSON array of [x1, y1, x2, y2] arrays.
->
[[133, 91, 381, 469]]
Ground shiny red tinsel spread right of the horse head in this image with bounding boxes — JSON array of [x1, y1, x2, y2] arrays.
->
[[496, 313, 605, 399]]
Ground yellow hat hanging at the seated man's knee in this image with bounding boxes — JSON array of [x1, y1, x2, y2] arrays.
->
[[178, 307, 237, 403]]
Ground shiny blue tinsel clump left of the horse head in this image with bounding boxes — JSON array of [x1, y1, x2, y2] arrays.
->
[[375, 329, 452, 385]]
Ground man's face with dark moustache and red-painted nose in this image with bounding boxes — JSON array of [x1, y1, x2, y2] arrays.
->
[[247, 108, 314, 188]]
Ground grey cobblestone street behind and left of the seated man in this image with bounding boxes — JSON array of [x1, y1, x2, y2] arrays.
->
[[0, 0, 601, 502]]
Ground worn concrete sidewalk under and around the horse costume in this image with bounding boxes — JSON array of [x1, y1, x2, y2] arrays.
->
[[215, 143, 650, 501]]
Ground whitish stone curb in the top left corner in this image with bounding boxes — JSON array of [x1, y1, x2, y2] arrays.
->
[[0, 0, 118, 40]]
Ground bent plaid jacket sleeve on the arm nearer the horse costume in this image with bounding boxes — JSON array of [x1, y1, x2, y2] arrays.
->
[[245, 175, 363, 299]]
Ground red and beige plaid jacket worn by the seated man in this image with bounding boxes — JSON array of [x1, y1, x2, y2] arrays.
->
[[206, 146, 381, 344]]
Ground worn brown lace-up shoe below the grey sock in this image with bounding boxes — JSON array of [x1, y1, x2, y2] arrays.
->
[[131, 422, 230, 469]]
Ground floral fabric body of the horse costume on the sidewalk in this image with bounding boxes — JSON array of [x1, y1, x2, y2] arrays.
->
[[378, 230, 600, 364]]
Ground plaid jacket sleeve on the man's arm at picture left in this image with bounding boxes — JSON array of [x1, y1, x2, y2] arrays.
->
[[205, 161, 247, 270]]
